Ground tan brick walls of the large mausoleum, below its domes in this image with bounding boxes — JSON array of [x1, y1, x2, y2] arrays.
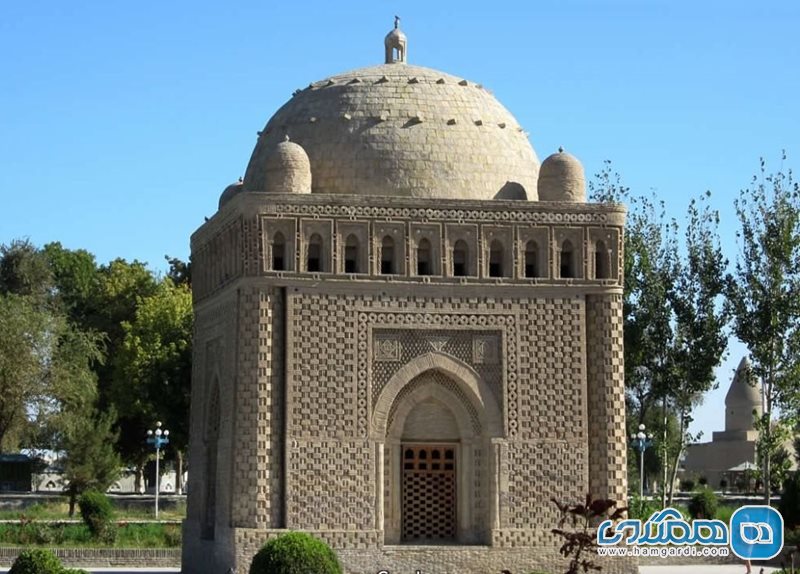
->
[[184, 194, 634, 572]]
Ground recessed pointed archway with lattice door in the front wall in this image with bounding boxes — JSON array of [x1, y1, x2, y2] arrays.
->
[[373, 353, 502, 544]]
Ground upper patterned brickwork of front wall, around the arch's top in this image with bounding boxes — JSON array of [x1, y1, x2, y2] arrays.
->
[[282, 295, 586, 440]]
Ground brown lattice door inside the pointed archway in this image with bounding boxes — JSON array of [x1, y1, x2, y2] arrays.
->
[[403, 445, 456, 542]]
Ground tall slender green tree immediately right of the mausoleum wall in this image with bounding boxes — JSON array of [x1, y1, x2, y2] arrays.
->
[[590, 168, 727, 505]]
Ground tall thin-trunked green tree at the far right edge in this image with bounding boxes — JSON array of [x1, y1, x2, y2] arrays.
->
[[728, 154, 800, 504]]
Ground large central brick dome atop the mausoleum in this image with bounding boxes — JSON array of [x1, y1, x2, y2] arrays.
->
[[244, 61, 539, 200]]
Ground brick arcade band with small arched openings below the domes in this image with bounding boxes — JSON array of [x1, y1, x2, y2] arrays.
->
[[192, 193, 624, 301]]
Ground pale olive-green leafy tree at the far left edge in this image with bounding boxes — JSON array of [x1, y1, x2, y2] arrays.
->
[[0, 241, 101, 448]]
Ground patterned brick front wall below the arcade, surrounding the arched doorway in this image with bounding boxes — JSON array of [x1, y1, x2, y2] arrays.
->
[[191, 288, 625, 574]]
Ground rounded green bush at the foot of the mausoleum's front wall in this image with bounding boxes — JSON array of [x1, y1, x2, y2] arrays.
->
[[250, 532, 342, 574]]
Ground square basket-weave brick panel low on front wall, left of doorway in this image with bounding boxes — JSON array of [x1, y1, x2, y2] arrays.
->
[[287, 440, 377, 530]]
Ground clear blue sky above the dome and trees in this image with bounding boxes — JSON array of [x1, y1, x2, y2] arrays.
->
[[0, 0, 800, 439]]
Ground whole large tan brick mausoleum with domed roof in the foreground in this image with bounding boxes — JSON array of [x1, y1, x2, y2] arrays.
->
[[183, 21, 635, 573]]
